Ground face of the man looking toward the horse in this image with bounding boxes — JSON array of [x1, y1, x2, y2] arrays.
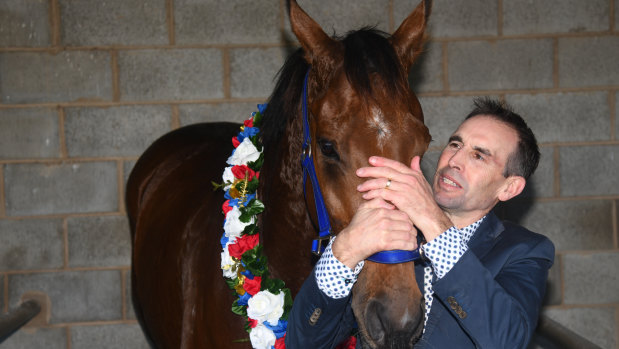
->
[[433, 115, 518, 217]]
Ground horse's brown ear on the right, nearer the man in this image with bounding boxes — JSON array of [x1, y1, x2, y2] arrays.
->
[[390, 0, 432, 73]]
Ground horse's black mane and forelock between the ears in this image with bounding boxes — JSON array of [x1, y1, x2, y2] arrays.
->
[[261, 27, 408, 148]]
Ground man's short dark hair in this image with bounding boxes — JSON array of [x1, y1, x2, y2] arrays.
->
[[465, 97, 540, 179]]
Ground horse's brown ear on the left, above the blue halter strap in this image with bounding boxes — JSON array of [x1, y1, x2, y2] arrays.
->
[[288, 0, 342, 81]]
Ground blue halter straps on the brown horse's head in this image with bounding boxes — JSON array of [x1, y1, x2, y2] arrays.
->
[[301, 69, 420, 264]]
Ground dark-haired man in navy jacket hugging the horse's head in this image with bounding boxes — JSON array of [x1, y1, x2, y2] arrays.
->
[[286, 99, 554, 348]]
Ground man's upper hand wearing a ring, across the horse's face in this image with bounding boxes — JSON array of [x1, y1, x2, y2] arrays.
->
[[357, 156, 453, 241]]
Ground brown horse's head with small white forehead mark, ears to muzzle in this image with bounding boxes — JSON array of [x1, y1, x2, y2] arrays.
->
[[290, 0, 431, 348]]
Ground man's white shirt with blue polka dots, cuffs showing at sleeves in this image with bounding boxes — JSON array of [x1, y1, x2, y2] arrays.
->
[[316, 216, 485, 324]]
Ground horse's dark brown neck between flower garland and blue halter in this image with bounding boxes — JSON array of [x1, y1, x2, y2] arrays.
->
[[259, 109, 315, 294]]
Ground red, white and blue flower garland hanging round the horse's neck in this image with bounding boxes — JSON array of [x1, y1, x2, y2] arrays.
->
[[218, 104, 292, 349]]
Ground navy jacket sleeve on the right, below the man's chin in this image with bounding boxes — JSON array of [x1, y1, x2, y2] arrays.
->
[[433, 235, 554, 348]]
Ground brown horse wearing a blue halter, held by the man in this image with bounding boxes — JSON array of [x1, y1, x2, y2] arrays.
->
[[126, 0, 431, 348]]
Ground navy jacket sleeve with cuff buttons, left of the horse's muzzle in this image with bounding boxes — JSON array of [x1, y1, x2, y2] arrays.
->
[[286, 270, 355, 349]]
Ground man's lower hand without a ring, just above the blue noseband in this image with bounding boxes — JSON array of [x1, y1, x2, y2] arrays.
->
[[331, 198, 417, 269]]
